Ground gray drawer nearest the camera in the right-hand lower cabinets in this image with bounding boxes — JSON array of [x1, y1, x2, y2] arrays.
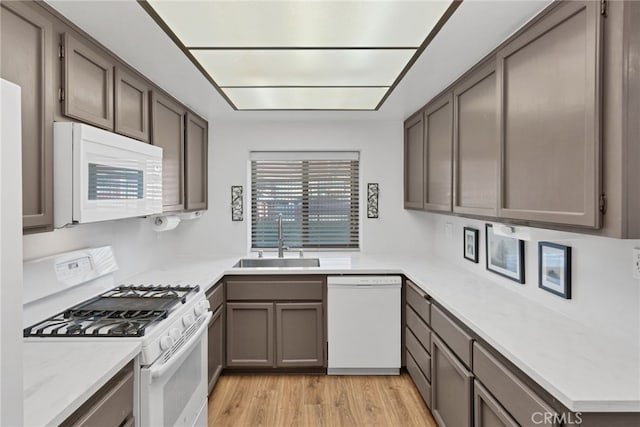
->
[[473, 343, 560, 426]]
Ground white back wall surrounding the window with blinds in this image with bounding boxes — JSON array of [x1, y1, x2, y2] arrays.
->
[[168, 120, 428, 254]]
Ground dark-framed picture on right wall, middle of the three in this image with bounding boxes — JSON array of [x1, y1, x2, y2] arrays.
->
[[484, 224, 524, 284]]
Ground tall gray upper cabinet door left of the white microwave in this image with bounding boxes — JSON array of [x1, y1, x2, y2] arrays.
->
[[0, 1, 55, 231]]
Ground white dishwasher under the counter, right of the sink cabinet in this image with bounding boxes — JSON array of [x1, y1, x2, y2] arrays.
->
[[327, 276, 402, 375]]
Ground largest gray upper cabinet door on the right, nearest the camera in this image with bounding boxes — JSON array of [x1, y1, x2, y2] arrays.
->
[[497, 1, 602, 228]]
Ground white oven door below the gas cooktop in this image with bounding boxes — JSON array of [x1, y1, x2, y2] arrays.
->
[[140, 312, 211, 427]]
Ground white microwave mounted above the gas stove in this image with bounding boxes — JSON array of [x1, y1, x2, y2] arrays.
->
[[53, 122, 162, 228]]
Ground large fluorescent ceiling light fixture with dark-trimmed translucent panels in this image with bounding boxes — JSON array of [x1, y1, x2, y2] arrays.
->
[[140, 0, 459, 110]]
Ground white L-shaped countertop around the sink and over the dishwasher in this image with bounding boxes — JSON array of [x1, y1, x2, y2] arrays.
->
[[140, 252, 640, 412]]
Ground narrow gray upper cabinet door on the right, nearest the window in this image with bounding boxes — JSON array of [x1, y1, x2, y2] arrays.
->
[[404, 112, 424, 209]]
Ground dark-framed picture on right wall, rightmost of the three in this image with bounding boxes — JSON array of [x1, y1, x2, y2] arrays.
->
[[538, 242, 571, 299]]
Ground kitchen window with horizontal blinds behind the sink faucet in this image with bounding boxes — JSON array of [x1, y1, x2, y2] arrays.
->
[[251, 152, 360, 249]]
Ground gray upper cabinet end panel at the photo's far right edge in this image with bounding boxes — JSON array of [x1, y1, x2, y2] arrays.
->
[[602, 1, 640, 239]]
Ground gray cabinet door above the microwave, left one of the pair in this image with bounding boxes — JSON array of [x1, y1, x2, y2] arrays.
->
[[63, 32, 113, 130]]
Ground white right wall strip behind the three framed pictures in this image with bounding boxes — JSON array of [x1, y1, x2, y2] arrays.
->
[[423, 213, 640, 344]]
